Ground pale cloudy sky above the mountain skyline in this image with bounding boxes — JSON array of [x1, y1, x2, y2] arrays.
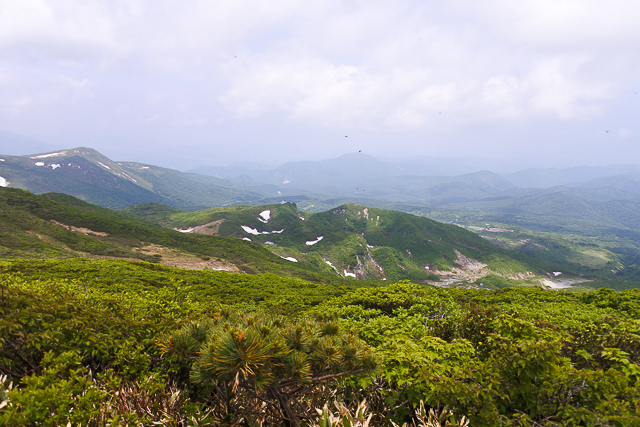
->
[[0, 0, 640, 170]]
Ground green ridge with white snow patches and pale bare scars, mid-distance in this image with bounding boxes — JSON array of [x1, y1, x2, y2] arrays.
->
[[123, 203, 561, 282]]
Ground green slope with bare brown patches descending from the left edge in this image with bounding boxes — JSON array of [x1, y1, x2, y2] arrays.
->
[[0, 188, 340, 281]]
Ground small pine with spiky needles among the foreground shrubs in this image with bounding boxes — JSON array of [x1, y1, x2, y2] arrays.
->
[[161, 312, 375, 427]]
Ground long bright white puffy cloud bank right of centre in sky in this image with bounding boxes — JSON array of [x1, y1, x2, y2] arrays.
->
[[220, 50, 612, 129]]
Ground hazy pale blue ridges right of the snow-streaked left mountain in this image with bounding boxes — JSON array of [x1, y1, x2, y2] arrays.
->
[[194, 153, 640, 206]]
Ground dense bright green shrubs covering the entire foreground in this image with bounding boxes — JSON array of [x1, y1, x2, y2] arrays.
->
[[0, 259, 640, 426]]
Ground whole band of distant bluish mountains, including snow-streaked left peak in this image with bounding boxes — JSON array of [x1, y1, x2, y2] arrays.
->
[[0, 147, 640, 211]]
